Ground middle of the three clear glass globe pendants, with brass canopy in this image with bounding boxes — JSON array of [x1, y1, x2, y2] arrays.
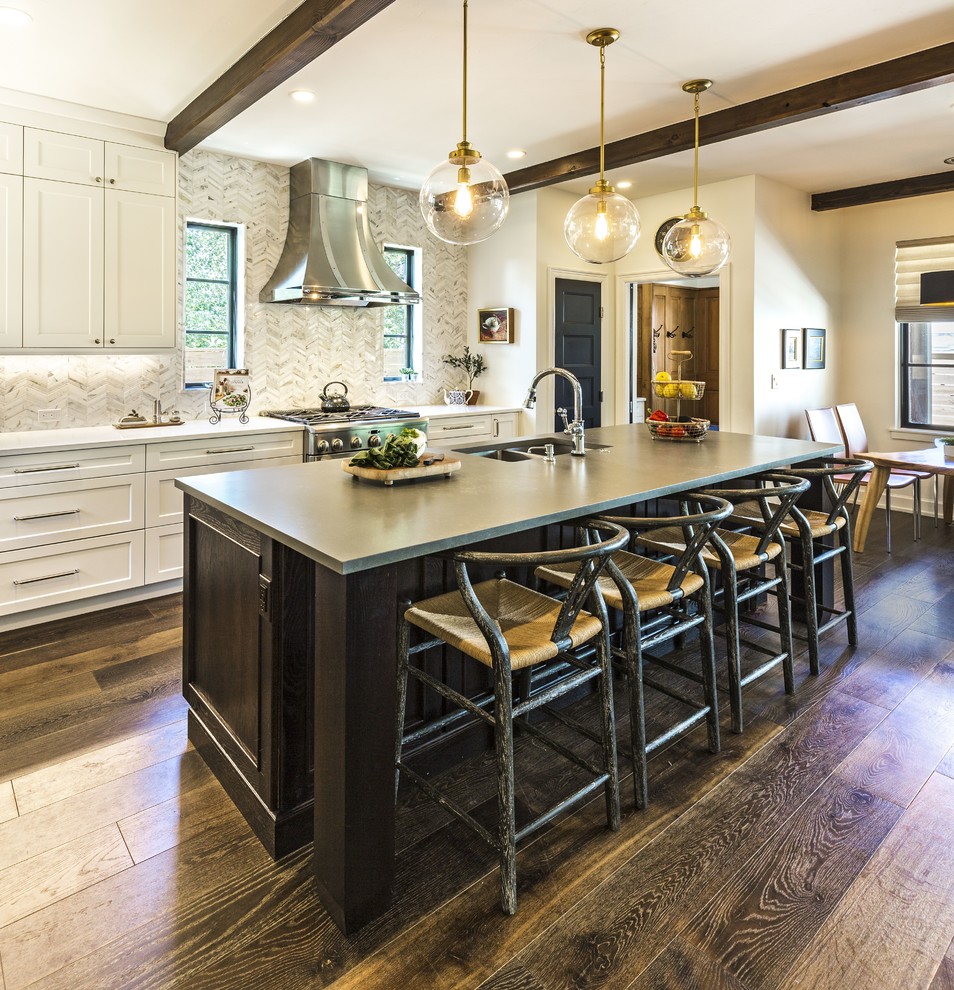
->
[[563, 28, 639, 265]]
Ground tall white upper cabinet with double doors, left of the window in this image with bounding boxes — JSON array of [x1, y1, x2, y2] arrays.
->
[[0, 125, 176, 351]]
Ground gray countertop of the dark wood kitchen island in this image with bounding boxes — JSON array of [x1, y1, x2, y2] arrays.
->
[[176, 425, 836, 574]]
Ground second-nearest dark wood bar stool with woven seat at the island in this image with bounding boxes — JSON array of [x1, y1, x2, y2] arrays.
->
[[536, 494, 732, 808]]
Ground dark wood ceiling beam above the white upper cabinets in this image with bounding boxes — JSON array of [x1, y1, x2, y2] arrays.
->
[[165, 0, 394, 155]]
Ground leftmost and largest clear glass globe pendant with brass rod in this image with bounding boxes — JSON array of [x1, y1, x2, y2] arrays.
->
[[419, 0, 510, 244]]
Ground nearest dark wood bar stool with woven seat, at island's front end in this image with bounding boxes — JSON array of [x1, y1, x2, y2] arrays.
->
[[395, 520, 629, 914]]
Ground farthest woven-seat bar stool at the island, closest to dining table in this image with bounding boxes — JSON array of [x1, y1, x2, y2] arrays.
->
[[730, 457, 872, 674]]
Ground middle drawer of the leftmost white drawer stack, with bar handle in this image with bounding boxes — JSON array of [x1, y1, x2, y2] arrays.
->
[[0, 474, 144, 551]]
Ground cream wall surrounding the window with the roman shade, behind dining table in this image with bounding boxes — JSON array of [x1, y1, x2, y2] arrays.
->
[[835, 192, 954, 450]]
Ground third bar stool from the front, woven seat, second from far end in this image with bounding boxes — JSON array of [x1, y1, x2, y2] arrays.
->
[[637, 473, 809, 732]]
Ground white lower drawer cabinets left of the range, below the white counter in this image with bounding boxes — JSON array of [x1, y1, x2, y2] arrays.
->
[[0, 431, 303, 616]]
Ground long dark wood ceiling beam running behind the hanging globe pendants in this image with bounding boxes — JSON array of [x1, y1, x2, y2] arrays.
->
[[505, 42, 954, 192]]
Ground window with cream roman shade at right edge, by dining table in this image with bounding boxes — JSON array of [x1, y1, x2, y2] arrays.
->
[[895, 236, 954, 430]]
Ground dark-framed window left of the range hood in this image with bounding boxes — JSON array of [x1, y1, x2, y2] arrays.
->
[[183, 220, 242, 389]]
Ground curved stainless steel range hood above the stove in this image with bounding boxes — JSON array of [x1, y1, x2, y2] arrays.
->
[[258, 158, 421, 306]]
